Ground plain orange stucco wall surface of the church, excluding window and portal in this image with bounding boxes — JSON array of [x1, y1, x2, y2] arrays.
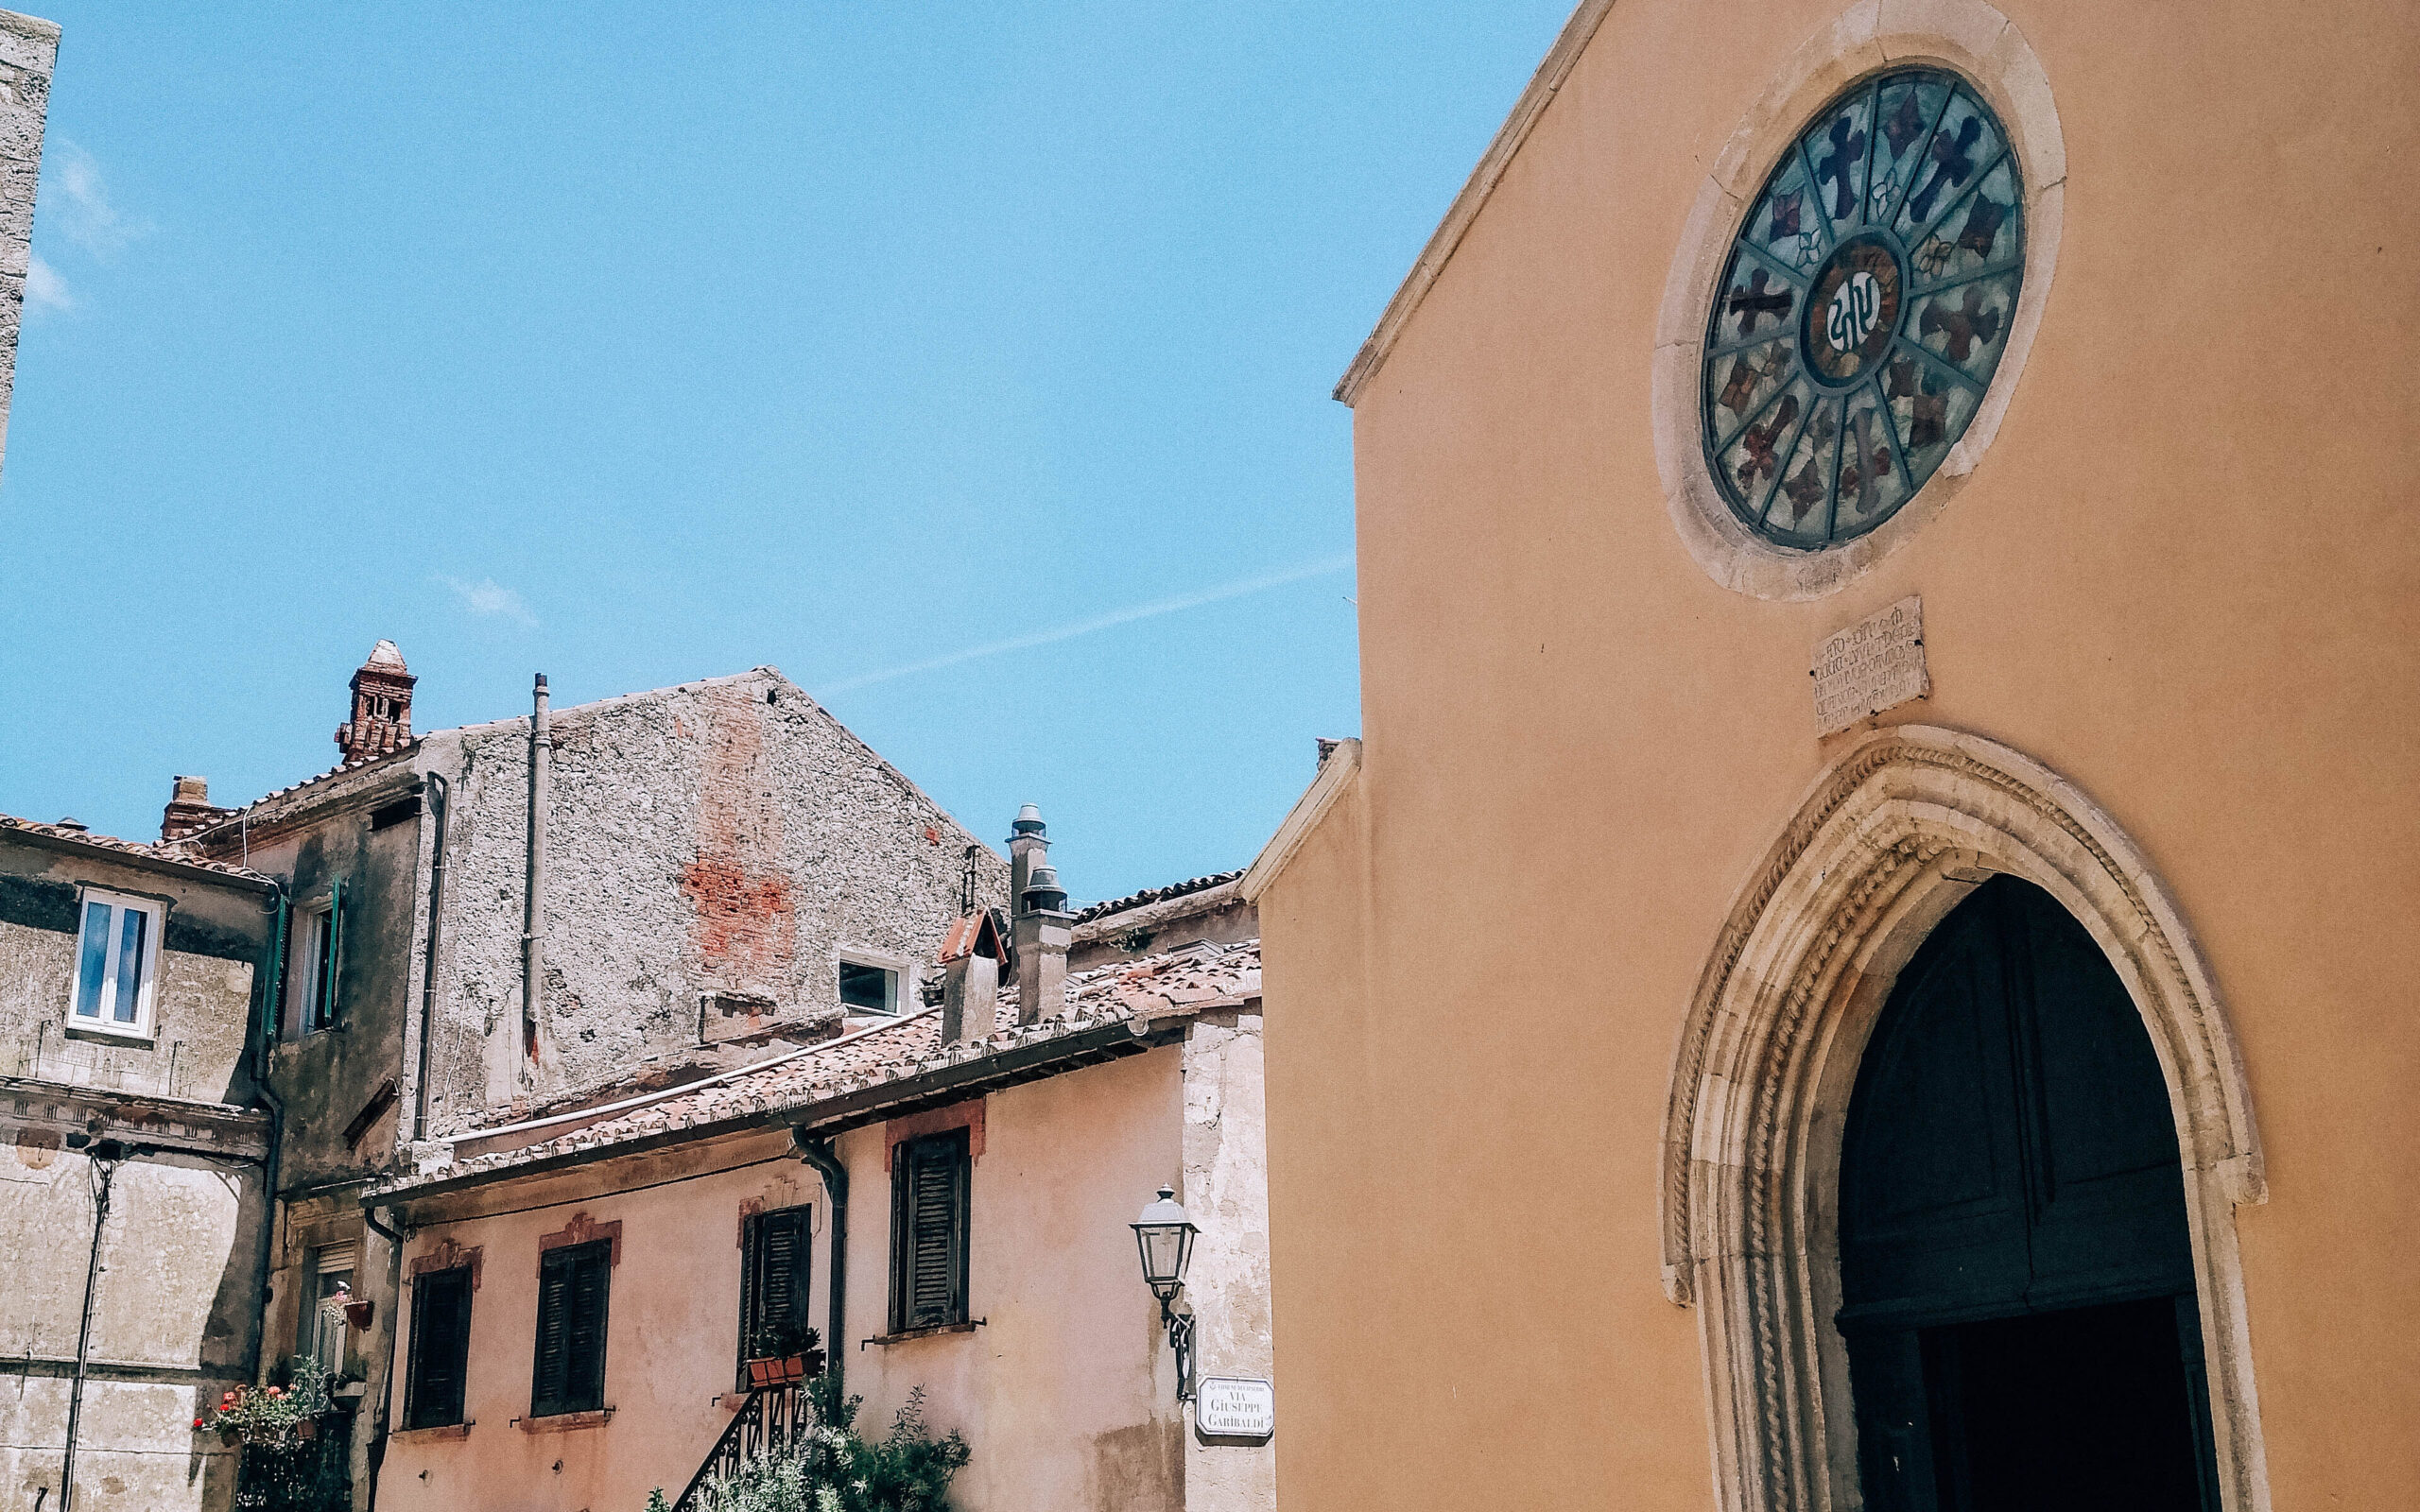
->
[[1261, 0, 2420, 1507]]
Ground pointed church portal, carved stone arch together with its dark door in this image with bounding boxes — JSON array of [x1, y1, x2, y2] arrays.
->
[[1663, 726, 2268, 1512]]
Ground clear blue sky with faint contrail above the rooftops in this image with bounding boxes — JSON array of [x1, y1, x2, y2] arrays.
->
[[0, 0, 1568, 898]]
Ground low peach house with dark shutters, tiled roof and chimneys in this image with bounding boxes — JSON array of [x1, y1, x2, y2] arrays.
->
[[363, 836, 1275, 1512]]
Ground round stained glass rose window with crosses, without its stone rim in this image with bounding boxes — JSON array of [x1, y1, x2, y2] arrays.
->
[[1702, 68, 2026, 552]]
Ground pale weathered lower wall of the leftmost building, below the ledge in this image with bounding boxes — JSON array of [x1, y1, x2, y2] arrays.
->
[[0, 1146, 264, 1512]]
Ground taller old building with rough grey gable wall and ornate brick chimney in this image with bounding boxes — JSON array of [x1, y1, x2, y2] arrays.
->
[[163, 641, 1007, 1498]]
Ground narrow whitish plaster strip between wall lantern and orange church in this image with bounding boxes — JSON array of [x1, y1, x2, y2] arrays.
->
[[1181, 1014, 1283, 1512]]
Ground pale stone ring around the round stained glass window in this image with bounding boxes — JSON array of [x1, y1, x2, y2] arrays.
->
[[1648, 0, 2066, 600]]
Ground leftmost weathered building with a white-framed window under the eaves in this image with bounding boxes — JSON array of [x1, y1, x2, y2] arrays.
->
[[0, 817, 276, 1512]]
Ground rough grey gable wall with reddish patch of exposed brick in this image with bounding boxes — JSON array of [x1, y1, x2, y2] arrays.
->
[[428, 673, 1007, 1130]]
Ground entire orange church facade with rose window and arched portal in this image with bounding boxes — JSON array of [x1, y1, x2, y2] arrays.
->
[[1244, 0, 2420, 1512]]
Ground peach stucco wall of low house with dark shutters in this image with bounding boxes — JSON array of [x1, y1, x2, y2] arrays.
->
[[380, 1047, 1184, 1512]]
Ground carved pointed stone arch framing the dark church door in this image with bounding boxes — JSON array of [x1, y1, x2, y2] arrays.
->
[[1663, 726, 2270, 1512]]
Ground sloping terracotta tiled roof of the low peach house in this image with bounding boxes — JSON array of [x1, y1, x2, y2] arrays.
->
[[377, 938, 1261, 1195]]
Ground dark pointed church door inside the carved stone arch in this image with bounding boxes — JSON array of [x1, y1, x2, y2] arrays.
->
[[1837, 876, 2220, 1512]]
